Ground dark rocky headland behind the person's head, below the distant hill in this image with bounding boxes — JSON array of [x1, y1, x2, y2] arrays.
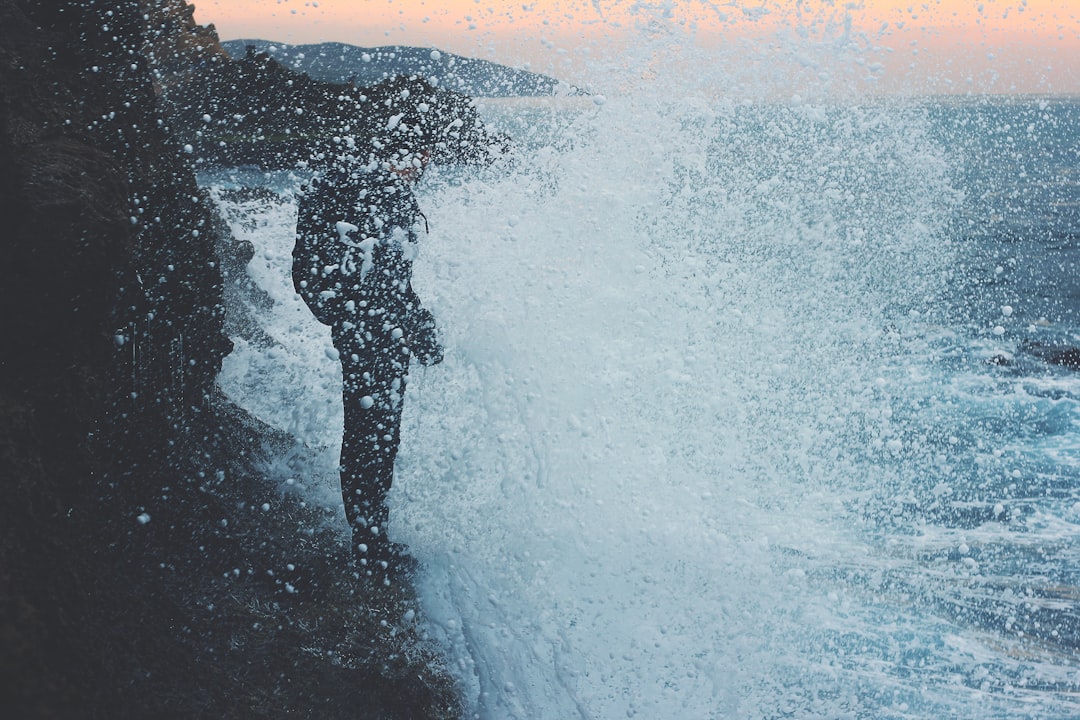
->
[[145, 0, 508, 169]]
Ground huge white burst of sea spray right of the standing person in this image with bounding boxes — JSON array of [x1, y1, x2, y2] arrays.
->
[[392, 83, 956, 717]]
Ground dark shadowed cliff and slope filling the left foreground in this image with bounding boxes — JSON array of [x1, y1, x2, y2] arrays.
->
[[0, 0, 460, 719]]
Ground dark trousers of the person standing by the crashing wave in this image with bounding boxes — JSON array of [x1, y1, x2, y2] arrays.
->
[[341, 347, 408, 552]]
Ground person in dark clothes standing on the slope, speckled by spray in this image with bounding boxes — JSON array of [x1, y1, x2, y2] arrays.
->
[[293, 79, 443, 582]]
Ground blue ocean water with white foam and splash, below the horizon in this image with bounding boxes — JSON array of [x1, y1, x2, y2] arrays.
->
[[203, 92, 1080, 720]]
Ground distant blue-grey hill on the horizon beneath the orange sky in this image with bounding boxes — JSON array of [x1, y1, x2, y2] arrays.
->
[[221, 40, 559, 97]]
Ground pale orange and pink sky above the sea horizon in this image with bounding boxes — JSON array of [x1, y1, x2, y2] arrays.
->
[[195, 0, 1080, 95]]
